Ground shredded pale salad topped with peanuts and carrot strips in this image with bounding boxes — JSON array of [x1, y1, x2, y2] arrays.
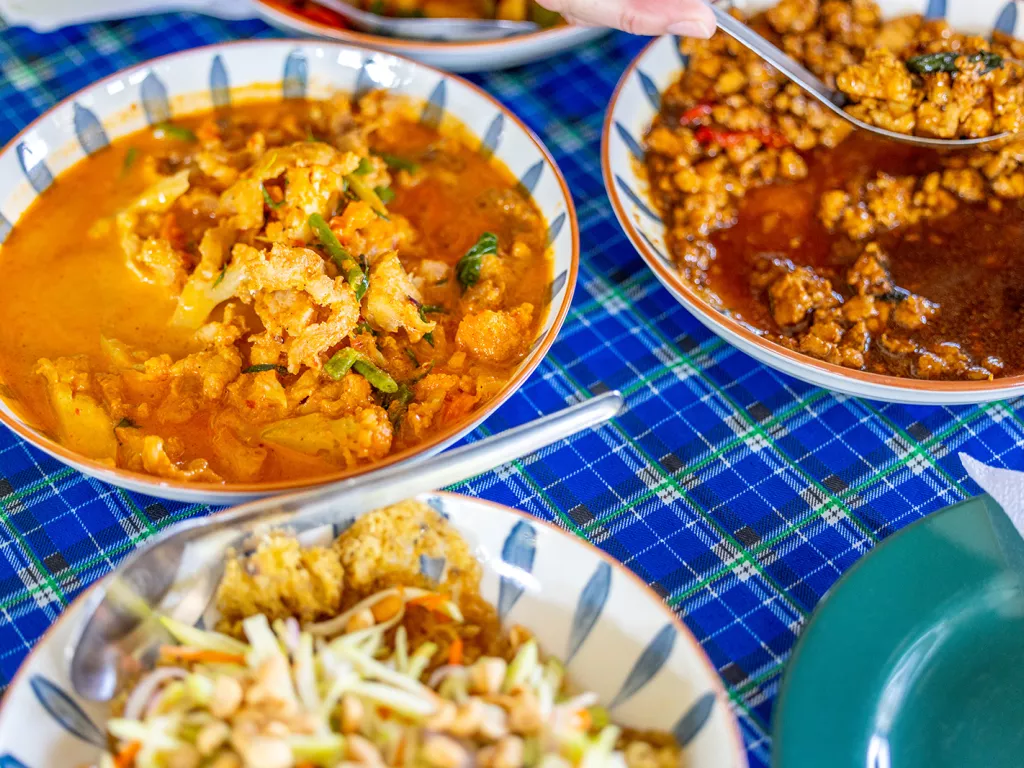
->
[[99, 588, 634, 768]]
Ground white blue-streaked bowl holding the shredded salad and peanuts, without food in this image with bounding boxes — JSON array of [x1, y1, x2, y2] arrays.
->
[[0, 494, 748, 768]]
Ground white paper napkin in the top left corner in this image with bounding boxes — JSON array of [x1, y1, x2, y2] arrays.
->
[[0, 0, 256, 32]]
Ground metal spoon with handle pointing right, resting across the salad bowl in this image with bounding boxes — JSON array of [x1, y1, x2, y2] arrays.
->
[[68, 392, 623, 701]]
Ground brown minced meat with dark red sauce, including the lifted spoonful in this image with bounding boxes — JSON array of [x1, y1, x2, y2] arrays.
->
[[646, 0, 1024, 380]]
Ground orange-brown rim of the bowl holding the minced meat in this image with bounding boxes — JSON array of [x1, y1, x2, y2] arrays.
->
[[601, 35, 1024, 402]]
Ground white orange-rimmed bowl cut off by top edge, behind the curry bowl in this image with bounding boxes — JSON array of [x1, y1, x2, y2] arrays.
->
[[253, 0, 608, 72]]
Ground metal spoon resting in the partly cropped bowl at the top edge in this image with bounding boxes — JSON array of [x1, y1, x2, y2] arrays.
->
[[313, 0, 540, 43]]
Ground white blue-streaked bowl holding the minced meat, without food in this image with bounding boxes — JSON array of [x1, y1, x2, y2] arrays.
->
[[601, 0, 1024, 404]]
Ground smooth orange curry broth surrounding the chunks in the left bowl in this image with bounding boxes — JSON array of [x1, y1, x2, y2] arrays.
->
[[0, 94, 552, 482]]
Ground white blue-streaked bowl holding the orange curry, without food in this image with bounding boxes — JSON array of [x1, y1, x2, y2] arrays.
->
[[0, 40, 580, 512]]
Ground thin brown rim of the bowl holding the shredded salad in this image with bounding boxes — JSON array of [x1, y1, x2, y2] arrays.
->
[[0, 490, 750, 768]]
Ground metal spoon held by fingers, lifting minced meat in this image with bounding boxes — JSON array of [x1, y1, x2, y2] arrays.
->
[[708, 3, 1010, 150]]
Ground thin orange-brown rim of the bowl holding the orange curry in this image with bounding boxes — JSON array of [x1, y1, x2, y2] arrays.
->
[[0, 38, 580, 504]]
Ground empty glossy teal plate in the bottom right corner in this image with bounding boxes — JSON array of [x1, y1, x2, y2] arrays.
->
[[773, 496, 1024, 768]]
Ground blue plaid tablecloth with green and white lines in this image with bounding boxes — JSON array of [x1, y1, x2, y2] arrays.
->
[[0, 15, 1024, 766]]
